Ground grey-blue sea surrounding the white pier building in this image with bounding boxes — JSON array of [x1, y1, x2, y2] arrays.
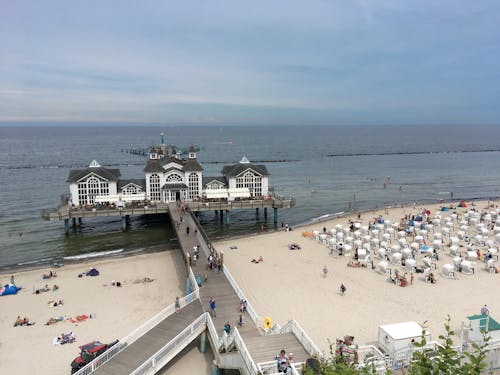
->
[[0, 123, 500, 273]]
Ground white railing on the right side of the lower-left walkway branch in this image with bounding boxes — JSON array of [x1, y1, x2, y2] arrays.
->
[[131, 313, 208, 375]]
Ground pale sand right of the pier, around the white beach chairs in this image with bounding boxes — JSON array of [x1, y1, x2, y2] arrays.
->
[[215, 202, 500, 351]]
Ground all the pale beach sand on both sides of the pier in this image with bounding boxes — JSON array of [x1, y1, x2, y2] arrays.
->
[[0, 202, 500, 375]]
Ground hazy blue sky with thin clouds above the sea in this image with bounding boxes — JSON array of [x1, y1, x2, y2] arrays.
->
[[0, 0, 500, 125]]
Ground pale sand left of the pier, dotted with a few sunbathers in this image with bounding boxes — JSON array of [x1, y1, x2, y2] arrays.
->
[[0, 251, 185, 375]]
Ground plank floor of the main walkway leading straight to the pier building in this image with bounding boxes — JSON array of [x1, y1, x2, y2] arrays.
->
[[169, 205, 309, 372]]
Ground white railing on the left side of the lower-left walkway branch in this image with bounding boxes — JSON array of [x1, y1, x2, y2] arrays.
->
[[75, 284, 200, 375]]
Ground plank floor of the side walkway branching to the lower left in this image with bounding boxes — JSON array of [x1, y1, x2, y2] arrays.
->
[[94, 300, 203, 375]]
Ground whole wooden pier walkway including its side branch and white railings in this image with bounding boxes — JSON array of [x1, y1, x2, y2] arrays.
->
[[75, 203, 320, 375]]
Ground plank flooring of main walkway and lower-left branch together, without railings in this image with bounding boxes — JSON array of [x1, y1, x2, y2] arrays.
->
[[90, 204, 309, 375]]
